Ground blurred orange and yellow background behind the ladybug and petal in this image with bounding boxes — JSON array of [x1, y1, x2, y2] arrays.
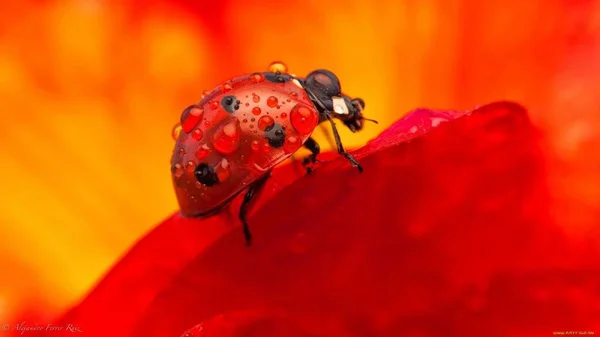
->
[[0, 0, 600, 323]]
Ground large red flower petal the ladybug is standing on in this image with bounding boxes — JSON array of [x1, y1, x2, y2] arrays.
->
[[48, 102, 600, 337]]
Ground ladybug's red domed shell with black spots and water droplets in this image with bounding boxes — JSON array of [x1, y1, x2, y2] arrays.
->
[[171, 73, 319, 216]]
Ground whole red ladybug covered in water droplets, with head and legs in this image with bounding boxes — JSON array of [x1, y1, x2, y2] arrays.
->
[[171, 63, 376, 245]]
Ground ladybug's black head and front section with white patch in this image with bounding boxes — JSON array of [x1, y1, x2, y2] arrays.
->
[[304, 69, 377, 132]]
